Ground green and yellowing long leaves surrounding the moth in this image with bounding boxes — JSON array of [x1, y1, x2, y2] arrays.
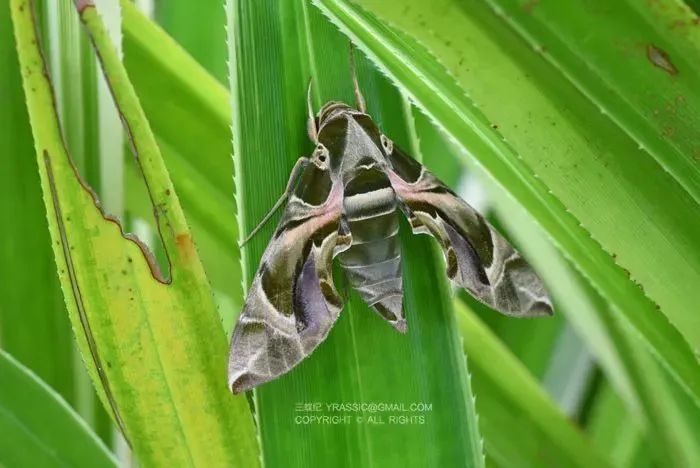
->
[[0, 0, 700, 467]]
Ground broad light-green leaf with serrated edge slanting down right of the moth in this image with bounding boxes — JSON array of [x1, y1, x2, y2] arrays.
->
[[316, 0, 700, 403]]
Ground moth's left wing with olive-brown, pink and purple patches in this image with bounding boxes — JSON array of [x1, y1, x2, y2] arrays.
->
[[228, 164, 351, 393]]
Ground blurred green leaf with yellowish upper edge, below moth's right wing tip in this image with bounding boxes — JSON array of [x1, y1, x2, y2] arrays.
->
[[455, 301, 608, 467]]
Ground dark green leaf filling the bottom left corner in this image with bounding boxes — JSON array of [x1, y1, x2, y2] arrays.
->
[[0, 350, 117, 467]]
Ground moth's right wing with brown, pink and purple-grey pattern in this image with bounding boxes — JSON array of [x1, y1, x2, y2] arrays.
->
[[388, 146, 552, 317]]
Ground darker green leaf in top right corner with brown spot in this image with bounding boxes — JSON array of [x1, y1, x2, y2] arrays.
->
[[488, 0, 700, 202]]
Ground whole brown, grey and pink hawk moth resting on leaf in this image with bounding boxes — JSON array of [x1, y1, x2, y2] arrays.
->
[[228, 69, 552, 393]]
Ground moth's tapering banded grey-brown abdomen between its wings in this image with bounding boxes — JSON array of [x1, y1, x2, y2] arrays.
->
[[338, 170, 406, 331]]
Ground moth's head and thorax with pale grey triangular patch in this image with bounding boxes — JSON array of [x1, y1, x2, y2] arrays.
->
[[318, 102, 387, 183]]
